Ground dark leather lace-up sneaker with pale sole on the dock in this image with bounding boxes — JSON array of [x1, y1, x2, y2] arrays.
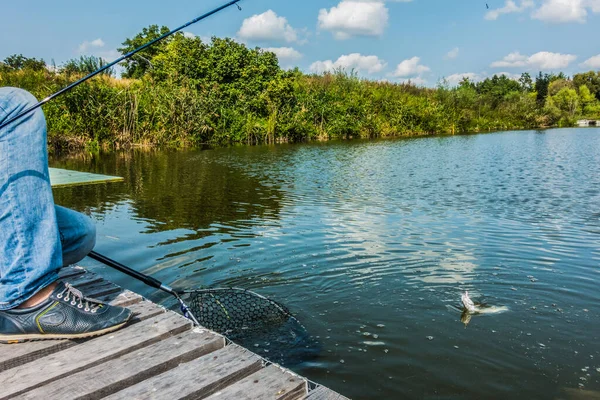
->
[[0, 282, 132, 343]]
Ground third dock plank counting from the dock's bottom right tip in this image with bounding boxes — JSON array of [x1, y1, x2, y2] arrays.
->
[[107, 345, 262, 400]]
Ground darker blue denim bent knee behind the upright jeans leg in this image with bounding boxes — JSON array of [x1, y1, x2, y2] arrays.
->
[[56, 206, 96, 266]]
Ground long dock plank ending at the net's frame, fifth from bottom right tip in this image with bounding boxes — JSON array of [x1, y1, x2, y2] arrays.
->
[[0, 313, 191, 399]]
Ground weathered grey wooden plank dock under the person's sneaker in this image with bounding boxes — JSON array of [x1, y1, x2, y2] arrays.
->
[[0, 267, 345, 400]]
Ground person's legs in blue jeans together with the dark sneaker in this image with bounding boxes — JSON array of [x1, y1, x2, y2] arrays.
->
[[0, 88, 131, 343]]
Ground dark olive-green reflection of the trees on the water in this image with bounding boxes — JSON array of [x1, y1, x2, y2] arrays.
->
[[53, 150, 281, 233]]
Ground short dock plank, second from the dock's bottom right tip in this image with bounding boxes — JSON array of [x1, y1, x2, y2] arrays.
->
[[208, 365, 307, 400]]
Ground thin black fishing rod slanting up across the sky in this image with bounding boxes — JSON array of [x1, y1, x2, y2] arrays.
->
[[0, 0, 241, 129]]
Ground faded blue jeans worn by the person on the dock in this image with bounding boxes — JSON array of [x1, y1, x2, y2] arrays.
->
[[0, 87, 96, 310]]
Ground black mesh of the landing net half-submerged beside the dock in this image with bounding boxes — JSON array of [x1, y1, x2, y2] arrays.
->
[[185, 288, 320, 366]]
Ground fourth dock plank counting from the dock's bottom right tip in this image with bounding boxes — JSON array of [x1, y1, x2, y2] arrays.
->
[[19, 329, 225, 400]]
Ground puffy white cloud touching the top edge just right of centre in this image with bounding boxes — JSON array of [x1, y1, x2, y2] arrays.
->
[[319, 0, 389, 40]]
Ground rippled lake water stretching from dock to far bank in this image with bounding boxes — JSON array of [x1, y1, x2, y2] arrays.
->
[[51, 128, 600, 399]]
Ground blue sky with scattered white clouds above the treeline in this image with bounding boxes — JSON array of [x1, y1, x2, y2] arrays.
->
[[0, 0, 600, 85]]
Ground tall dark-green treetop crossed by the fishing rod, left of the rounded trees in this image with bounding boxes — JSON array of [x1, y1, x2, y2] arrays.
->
[[117, 25, 172, 79]]
